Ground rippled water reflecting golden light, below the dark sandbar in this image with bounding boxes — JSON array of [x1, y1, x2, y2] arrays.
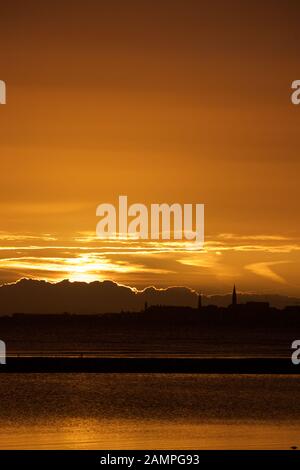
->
[[0, 373, 300, 449]]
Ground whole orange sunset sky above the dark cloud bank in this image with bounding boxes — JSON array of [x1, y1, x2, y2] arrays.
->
[[0, 0, 300, 295]]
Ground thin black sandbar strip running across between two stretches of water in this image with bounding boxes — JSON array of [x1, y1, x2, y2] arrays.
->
[[0, 357, 300, 374]]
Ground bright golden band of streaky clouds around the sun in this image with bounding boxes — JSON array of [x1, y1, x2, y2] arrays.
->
[[0, 233, 300, 293]]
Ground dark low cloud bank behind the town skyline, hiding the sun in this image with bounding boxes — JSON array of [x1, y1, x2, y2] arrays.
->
[[0, 279, 300, 315]]
